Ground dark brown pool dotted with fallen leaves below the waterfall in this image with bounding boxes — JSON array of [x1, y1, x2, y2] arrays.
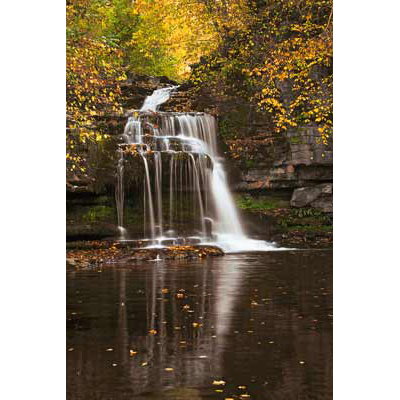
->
[[67, 250, 332, 400]]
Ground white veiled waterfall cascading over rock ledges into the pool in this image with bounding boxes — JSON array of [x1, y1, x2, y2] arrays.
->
[[116, 86, 276, 252]]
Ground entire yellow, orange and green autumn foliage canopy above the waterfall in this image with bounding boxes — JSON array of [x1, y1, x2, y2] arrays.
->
[[67, 0, 332, 174]]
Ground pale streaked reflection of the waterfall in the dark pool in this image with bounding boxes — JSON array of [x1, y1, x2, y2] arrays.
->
[[115, 259, 244, 394]]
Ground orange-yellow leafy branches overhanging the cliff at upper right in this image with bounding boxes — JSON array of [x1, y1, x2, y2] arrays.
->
[[191, 0, 333, 143]]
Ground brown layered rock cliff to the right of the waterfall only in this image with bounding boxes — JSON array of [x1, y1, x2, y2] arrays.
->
[[164, 86, 333, 212]]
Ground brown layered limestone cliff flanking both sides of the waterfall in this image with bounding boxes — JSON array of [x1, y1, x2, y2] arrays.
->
[[67, 76, 333, 240]]
